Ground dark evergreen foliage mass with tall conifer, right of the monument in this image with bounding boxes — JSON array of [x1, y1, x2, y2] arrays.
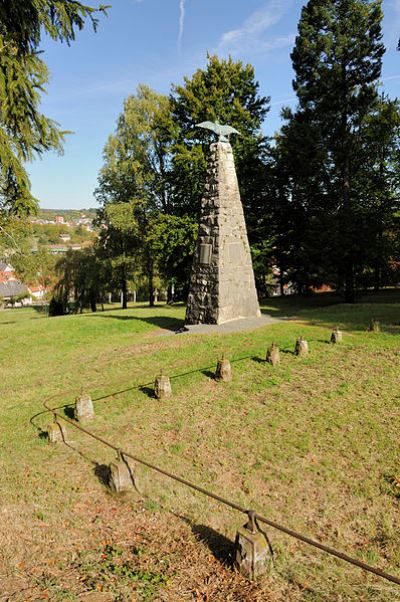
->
[[269, 0, 399, 301]]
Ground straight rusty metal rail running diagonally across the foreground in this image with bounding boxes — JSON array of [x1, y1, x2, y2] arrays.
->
[[43, 396, 400, 585]]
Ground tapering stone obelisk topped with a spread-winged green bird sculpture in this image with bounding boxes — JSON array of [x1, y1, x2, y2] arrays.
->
[[185, 122, 261, 325]]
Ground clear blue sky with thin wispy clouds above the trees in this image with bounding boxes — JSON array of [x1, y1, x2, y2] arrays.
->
[[28, 0, 400, 209]]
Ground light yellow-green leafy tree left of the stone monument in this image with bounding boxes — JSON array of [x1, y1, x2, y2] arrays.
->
[[96, 86, 198, 306]]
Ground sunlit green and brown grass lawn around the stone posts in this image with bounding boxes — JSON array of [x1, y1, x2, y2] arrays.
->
[[0, 291, 400, 602]]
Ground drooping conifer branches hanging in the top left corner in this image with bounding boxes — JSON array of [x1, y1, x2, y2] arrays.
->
[[0, 0, 105, 215]]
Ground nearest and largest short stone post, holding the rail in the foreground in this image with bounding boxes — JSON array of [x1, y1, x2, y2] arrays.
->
[[234, 513, 272, 581]]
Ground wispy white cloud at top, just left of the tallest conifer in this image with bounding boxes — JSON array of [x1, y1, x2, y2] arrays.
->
[[218, 0, 292, 55]]
